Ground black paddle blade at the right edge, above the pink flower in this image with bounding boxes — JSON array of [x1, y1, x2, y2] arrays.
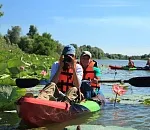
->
[[125, 77, 150, 87]]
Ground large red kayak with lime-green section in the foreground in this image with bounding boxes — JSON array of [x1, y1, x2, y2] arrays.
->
[[16, 97, 101, 127]]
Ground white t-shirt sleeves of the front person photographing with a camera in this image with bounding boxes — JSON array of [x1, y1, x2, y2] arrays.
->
[[49, 61, 83, 82]]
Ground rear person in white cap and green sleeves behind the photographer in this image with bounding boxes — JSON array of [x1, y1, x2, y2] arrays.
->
[[80, 51, 105, 103]]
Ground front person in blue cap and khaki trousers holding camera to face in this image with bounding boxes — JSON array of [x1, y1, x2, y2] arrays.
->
[[38, 45, 83, 100]]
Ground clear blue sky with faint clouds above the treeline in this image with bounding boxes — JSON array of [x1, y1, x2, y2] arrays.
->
[[0, 0, 150, 55]]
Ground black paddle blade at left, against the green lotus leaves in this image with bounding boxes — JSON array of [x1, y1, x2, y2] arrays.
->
[[16, 78, 40, 88]]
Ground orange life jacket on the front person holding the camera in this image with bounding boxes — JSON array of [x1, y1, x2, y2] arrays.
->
[[57, 66, 74, 93]]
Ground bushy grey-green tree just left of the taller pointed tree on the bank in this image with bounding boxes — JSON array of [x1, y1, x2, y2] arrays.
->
[[6, 26, 21, 44]]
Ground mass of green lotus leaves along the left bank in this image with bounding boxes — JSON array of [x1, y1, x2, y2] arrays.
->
[[0, 31, 59, 110]]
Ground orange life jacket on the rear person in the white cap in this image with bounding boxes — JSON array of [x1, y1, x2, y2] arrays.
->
[[83, 61, 100, 88]]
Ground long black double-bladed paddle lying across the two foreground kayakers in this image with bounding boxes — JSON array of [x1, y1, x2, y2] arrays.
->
[[16, 77, 150, 88]]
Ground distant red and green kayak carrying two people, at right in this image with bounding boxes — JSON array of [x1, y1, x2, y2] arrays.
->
[[109, 65, 150, 70]]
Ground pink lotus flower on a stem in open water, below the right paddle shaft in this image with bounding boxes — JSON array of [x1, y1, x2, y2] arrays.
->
[[112, 84, 127, 96]]
